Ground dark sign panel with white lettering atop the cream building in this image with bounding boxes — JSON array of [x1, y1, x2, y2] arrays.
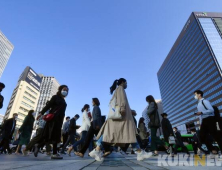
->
[[19, 67, 42, 91]]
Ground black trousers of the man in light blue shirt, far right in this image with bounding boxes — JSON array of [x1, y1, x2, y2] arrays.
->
[[200, 116, 222, 152]]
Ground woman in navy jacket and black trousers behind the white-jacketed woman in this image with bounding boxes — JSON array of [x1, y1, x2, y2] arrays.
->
[[73, 98, 102, 157]]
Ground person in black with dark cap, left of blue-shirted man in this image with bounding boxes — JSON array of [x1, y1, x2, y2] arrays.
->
[[161, 113, 174, 157]]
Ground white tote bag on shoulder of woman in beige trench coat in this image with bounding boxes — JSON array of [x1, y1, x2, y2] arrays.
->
[[108, 98, 122, 120]]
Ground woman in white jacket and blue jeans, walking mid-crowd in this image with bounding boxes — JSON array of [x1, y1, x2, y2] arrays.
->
[[68, 104, 90, 155]]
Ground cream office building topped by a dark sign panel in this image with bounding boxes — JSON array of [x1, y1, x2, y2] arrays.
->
[[5, 67, 42, 128]]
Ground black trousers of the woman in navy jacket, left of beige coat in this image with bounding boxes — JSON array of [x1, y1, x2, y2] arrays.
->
[[79, 124, 100, 155]]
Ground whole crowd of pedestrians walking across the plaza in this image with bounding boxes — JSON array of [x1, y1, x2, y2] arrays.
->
[[0, 78, 222, 161]]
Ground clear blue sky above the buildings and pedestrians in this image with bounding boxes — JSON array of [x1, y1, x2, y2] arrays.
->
[[0, 0, 222, 124]]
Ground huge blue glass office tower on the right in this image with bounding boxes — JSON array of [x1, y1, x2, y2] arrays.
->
[[157, 12, 222, 133]]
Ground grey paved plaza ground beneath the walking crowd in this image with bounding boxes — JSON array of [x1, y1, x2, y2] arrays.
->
[[0, 152, 221, 170]]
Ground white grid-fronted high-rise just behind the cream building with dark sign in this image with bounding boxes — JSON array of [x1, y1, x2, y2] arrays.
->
[[36, 75, 60, 113]]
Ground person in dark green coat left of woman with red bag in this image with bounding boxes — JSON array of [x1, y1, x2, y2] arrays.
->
[[15, 110, 35, 154]]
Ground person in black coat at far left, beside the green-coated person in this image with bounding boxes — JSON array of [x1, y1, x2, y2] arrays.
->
[[0, 113, 18, 154]]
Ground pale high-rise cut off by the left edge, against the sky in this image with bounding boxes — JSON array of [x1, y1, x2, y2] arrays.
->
[[0, 31, 14, 78]]
